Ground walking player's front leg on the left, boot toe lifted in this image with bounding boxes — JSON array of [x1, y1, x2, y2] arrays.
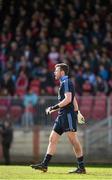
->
[[31, 130, 60, 172]]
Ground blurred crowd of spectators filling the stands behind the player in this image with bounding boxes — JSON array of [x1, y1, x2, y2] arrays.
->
[[0, 0, 112, 96]]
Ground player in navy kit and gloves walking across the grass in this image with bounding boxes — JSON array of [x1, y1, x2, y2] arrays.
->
[[31, 63, 86, 174]]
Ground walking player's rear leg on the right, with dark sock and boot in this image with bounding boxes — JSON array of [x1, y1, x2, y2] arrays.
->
[[66, 131, 86, 173]]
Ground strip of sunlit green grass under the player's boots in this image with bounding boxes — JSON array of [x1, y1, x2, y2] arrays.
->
[[0, 165, 112, 180]]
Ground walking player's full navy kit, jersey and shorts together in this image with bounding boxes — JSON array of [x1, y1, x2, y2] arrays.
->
[[53, 76, 77, 135]]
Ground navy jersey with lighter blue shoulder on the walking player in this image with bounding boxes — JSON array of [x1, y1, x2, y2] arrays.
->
[[58, 76, 75, 113]]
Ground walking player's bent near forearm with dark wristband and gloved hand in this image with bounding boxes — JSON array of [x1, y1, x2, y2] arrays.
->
[[46, 92, 72, 114]]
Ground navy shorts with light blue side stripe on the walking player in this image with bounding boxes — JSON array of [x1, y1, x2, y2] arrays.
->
[[53, 111, 77, 135]]
